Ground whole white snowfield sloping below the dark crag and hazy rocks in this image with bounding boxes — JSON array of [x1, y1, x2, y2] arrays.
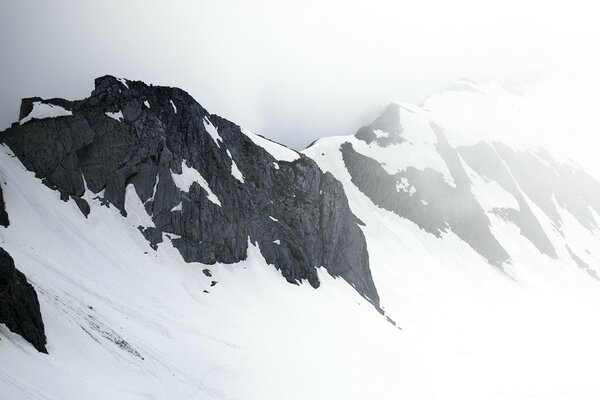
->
[[0, 138, 600, 400]]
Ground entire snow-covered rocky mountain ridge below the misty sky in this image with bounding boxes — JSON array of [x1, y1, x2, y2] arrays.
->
[[0, 76, 600, 399]]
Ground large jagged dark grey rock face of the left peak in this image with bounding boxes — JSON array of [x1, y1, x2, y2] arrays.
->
[[0, 76, 379, 307]]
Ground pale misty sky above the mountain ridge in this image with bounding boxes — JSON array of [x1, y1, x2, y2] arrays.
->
[[0, 0, 600, 148]]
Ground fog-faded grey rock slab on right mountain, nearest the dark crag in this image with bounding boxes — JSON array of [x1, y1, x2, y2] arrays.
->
[[340, 138, 510, 267]]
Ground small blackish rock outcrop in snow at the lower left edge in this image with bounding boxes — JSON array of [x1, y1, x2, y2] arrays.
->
[[0, 247, 47, 353]]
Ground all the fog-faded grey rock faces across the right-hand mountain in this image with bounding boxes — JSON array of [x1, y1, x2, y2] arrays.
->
[[340, 105, 600, 266]]
